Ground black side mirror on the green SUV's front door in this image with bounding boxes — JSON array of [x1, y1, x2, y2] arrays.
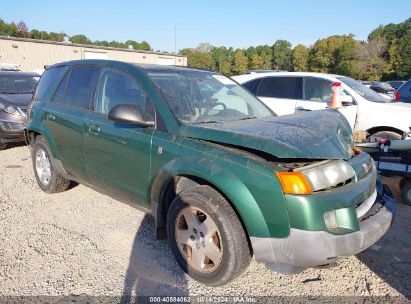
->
[[108, 104, 155, 127]]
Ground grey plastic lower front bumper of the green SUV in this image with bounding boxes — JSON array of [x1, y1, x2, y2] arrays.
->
[[250, 190, 393, 273]]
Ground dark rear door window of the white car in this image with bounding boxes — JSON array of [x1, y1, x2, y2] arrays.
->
[[257, 77, 301, 99]]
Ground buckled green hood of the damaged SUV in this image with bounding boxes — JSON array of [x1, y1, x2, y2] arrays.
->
[[179, 110, 353, 159]]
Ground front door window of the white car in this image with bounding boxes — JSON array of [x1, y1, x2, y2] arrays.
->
[[303, 77, 333, 102]]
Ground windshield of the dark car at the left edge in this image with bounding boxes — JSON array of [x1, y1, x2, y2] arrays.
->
[[0, 75, 40, 94]]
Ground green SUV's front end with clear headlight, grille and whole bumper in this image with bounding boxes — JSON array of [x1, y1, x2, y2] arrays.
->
[[251, 153, 395, 273]]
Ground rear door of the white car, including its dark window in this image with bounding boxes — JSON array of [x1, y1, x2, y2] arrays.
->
[[256, 76, 302, 115]]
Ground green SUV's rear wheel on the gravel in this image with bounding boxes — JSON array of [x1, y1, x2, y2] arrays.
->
[[31, 136, 70, 193]]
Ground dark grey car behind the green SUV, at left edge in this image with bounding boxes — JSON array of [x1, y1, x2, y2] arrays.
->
[[0, 71, 40, 150]]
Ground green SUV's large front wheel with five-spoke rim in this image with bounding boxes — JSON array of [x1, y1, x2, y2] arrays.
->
[[167, 185, 251, 286]]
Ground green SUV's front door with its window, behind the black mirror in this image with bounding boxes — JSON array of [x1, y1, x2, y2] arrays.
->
[[84, 67, 155, 207]]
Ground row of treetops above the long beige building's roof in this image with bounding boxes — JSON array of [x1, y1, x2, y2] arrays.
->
[[0, 19, 152, 51]]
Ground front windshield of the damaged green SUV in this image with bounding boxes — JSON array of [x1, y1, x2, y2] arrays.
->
[[147, 70, 274, 124]]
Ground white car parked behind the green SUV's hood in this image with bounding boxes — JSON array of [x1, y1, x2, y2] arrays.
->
[[232, 72, 411, 138]]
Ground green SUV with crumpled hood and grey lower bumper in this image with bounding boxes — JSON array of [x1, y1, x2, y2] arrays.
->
[[28, 60, 392, 285]]
